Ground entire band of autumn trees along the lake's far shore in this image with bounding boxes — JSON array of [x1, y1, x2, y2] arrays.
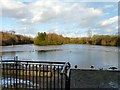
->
[[0, 32, 120, 46]]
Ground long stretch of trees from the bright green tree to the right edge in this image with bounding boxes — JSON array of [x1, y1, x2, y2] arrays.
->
[[34, 32, 120, 46]]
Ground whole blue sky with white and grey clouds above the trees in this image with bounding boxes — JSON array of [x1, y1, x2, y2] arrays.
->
[[0, 0, 118, 37]]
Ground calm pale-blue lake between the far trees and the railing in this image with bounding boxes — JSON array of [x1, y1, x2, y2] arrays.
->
[[1, 44, 120, 70]]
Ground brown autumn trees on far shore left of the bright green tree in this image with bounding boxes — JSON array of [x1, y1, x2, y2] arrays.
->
[[0, 32, 33, 46]]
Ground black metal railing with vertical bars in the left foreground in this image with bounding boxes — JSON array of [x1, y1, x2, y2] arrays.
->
[[1, 57, 70, 90]]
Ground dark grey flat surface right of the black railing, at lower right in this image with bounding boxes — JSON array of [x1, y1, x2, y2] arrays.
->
[[70, 69, 120, 88]]
